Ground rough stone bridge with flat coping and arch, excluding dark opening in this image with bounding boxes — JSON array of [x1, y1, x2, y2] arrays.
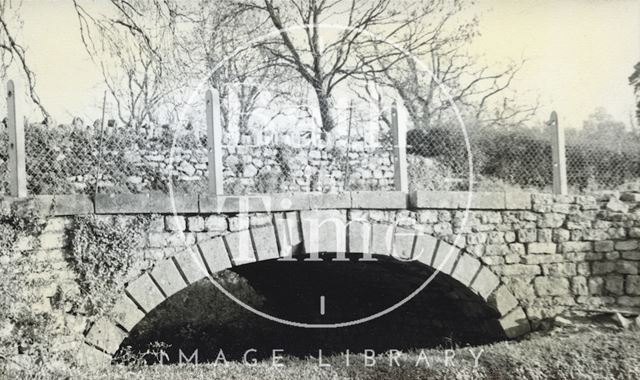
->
[[3, 191, 640, 363]]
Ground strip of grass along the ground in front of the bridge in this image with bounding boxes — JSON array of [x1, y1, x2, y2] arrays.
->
[[5, 331, 640, 380]]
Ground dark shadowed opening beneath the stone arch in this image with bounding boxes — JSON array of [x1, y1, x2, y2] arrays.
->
[[120, 254, 504, 363]]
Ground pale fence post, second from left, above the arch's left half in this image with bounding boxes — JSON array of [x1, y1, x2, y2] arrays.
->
[[206, 88, 224, 195]]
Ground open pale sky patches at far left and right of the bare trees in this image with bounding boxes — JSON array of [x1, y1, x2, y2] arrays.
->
[[5, 0, 640, 127]]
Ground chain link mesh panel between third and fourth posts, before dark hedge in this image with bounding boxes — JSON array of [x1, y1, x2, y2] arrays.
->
[[407, 125, 553, 191]]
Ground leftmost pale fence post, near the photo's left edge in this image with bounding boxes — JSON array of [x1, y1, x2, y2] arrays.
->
[[7, 80, 27, 198]]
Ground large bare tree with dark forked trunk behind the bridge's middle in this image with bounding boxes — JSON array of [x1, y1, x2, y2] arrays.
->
[[239, 0, 423, 133]]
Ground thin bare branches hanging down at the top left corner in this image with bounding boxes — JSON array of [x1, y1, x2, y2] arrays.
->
[[0, 0, 51, 123]]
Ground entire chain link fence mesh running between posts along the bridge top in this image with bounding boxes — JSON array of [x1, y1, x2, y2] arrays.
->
[[8, 103, 640, 195]]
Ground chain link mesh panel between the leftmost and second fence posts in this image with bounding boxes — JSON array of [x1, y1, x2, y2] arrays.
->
[[25, 125, 207, 194]]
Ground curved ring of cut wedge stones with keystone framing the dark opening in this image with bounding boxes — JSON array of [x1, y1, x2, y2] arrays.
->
[[78, 210, 530, 364]]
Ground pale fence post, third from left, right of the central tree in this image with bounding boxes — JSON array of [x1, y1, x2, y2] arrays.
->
[[391, 100, 409, 192]]
